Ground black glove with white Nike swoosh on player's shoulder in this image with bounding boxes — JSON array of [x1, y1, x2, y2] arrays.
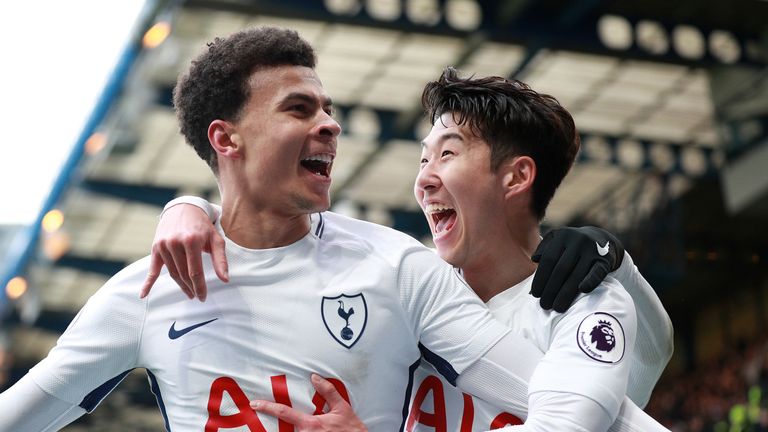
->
[[531, 226, 624, 312]]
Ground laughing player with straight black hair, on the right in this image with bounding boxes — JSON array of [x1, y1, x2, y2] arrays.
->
[[144, 30, 671, 430]]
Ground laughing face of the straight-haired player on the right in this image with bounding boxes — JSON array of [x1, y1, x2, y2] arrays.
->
[[414, 113, 504, 268]]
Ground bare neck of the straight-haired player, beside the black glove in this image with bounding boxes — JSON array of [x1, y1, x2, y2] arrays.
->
[[462, 211, 540, 302]]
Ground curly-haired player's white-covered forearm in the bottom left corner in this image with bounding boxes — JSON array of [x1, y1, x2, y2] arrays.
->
[[0, 376, 86, 431]]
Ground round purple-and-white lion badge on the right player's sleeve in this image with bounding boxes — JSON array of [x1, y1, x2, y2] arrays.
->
[[576, 312, 624, 363]]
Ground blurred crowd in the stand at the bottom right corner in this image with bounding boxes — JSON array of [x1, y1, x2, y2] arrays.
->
[[646, 337, 768, 432]]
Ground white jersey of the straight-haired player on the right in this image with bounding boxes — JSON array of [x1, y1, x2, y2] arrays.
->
[[404, 275, 637, 432]]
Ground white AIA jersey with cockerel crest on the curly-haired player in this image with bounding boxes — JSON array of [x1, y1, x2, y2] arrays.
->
[[30, 212, 509, 432]]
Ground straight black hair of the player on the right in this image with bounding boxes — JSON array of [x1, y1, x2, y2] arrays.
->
[[421, 67, 581, 220]]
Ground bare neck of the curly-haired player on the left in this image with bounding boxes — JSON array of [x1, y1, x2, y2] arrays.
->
[[221, 196, 310, 249]]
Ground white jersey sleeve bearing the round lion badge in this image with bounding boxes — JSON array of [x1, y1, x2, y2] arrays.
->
[[529, 277, 637, 420]]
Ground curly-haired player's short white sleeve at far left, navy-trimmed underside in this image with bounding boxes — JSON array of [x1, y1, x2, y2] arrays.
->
[[29, 259, 149, 412]]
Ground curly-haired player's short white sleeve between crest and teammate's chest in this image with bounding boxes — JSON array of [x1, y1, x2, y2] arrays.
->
[[398, 248, 509, 385]]
